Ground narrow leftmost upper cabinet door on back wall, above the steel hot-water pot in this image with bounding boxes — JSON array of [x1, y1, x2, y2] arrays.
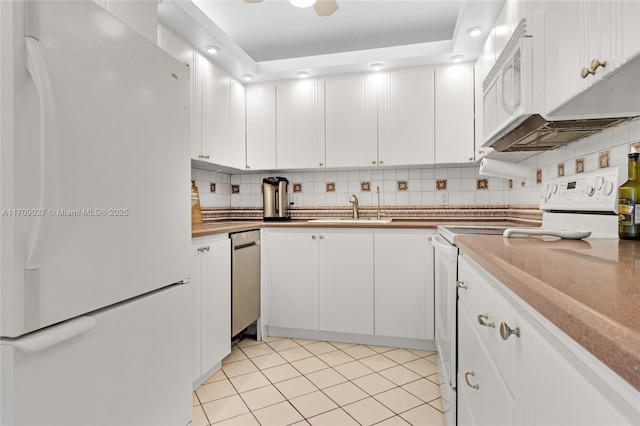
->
[[246, 83, 276, 170]]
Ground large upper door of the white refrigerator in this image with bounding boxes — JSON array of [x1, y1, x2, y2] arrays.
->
[[1, 1, 191, 337]]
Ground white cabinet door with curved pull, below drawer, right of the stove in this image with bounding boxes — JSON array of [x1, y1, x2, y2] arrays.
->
[[458, 303, 516, 425]]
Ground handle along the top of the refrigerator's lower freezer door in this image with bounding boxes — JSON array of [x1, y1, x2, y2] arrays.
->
[[2, 317, 96, 354]]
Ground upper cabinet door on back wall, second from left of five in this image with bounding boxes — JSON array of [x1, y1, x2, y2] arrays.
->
[[276, 80, 325, 169]]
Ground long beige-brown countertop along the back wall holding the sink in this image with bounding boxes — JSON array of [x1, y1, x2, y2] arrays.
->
[[191, 218, 531, 238]]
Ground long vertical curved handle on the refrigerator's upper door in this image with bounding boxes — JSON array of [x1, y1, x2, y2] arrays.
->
[[25, 37, 58, 270]]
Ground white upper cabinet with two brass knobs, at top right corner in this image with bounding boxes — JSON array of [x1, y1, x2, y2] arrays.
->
[[545, 0, 640, 116]]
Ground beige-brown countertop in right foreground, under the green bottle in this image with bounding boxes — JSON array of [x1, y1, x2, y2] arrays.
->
[[456, 235, 640, 390]]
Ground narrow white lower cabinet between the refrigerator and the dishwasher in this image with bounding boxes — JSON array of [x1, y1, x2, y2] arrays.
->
[[191, 234, 231, 389]]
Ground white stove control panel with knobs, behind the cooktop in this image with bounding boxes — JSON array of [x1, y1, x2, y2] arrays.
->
[[540, 167, 623, 213]]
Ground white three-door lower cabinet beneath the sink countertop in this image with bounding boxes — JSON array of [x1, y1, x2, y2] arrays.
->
[[263, 229, 434, 340]]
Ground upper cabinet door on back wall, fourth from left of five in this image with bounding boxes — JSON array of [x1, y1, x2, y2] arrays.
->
[[377, 67, 434, 166]]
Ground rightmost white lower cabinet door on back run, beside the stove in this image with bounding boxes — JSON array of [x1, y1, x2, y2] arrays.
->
[[374, 234, 434, 339]]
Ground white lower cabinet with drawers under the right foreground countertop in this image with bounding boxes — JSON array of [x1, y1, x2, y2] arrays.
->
[[457, 253, 640, 425]]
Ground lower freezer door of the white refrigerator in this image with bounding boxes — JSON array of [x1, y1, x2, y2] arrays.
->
[[0, 285, 192, 426]]
